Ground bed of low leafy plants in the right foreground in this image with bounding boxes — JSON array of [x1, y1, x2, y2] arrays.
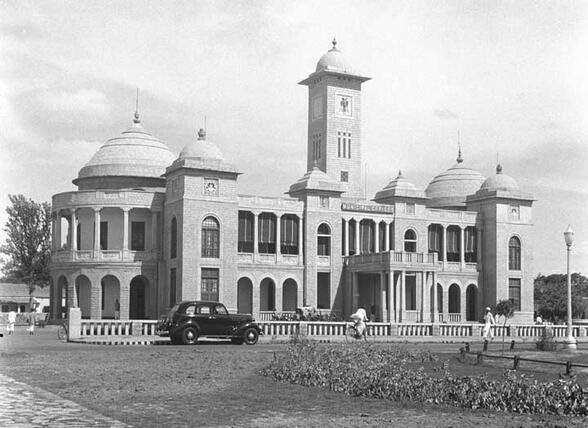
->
[[262, 343, 588, 416]]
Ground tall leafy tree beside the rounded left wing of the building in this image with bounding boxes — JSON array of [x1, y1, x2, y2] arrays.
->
[[0, 195, 51, 293]]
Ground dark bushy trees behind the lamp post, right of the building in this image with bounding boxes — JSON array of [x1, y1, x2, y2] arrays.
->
[[534, 273, 588, 323]]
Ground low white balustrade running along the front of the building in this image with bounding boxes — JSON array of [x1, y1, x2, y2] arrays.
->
[[63, 310, 588, 341]]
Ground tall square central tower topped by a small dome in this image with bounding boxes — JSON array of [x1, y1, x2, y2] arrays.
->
[[300, 40, 369, 198]]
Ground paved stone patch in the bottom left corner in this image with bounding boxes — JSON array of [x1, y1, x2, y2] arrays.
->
[[0, 374, 130, 428]]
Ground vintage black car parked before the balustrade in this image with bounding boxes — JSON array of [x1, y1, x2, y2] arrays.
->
[[157, 301, 262, 345]]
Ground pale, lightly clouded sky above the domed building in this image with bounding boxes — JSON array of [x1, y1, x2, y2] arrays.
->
[[0, 0, 588, 274]]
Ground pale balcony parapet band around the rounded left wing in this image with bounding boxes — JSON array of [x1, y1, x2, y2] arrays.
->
[[51, 250, 159, 263]]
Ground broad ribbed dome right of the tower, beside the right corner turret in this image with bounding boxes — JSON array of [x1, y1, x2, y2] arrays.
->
[[425, 150, 485, 209]]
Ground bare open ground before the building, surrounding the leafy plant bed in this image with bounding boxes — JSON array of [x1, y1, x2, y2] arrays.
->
[[0, 327, 586, 428]]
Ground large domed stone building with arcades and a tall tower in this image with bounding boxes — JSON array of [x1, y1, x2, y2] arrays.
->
[[51, 41, 533, 322]]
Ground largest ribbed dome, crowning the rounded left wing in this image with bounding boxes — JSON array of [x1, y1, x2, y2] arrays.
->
[[73, 113, 174, 188]]
